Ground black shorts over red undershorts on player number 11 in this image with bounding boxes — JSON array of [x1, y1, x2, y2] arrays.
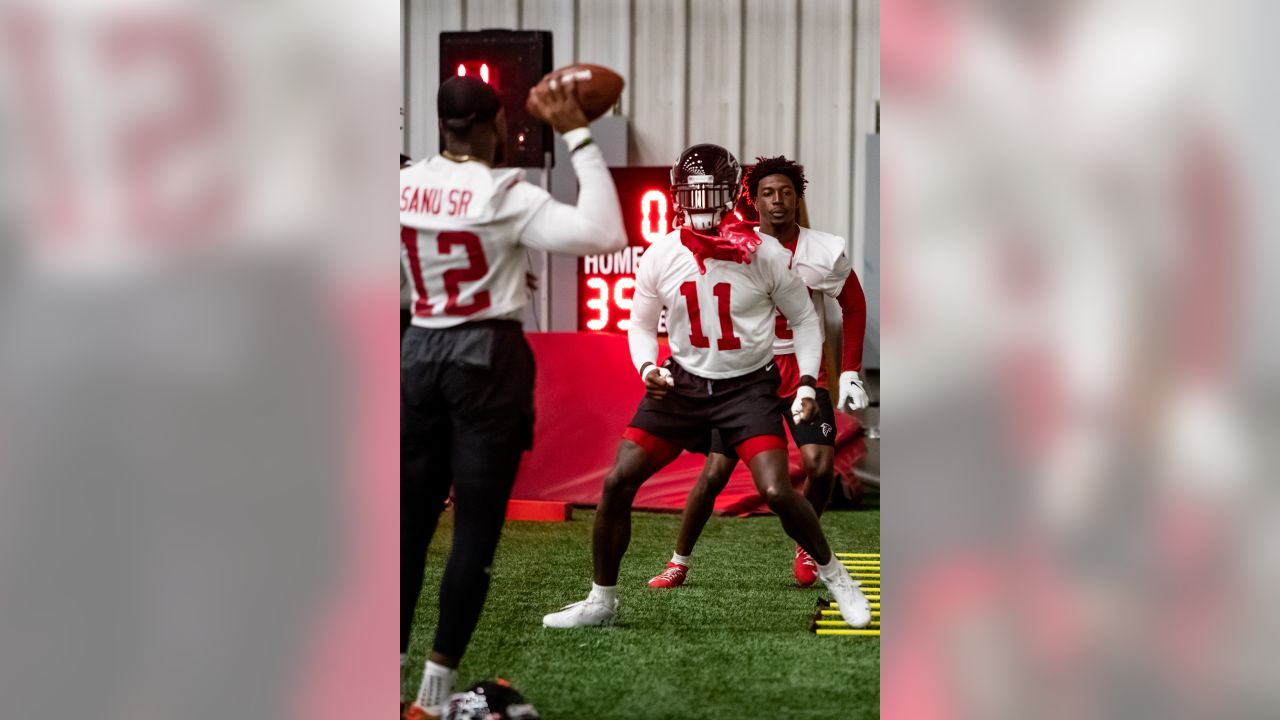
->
[[631, 357, 785, 454]]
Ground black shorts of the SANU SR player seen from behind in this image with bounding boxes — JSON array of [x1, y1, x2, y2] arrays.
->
[[401, 320, 534, 456]]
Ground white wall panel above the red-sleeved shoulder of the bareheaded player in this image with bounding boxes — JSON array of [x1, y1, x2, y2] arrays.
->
[[796, 0, 855, 241]]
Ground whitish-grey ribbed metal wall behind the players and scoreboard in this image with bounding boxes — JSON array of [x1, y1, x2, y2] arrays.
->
[[401, 0, 879, 269]]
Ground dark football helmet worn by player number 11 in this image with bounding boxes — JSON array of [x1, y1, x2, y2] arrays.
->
[[671, 145, 742, 232]]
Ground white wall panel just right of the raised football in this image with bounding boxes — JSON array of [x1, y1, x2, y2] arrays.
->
[[628, 0, 689, 165]]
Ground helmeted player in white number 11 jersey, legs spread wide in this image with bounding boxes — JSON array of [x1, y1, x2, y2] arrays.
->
[[543, 145, 870, 628]]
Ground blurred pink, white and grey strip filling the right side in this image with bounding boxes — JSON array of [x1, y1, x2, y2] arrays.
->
[[881, 0, 1280, 719]]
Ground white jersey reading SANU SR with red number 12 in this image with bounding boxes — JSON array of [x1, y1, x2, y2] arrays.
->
[[399, 128, 626, 328]]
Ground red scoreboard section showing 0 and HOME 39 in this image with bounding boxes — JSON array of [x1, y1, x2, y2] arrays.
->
[[577, 167, 672, 333]]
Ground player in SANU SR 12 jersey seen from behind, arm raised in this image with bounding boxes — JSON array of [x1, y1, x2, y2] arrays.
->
[[399, 76, 626, 719]]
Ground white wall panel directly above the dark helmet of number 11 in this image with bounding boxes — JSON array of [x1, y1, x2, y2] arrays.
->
[[673, 0, 742, 152]]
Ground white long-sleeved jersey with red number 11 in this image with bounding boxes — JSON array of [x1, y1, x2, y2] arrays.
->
[[631, 229, 822, 379]]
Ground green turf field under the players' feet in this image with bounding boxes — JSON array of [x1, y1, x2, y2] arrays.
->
[[403, 510, 879, 720]]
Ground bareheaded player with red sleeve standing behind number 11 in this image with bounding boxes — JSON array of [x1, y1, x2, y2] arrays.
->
[[649, 156, 867, 588]]
